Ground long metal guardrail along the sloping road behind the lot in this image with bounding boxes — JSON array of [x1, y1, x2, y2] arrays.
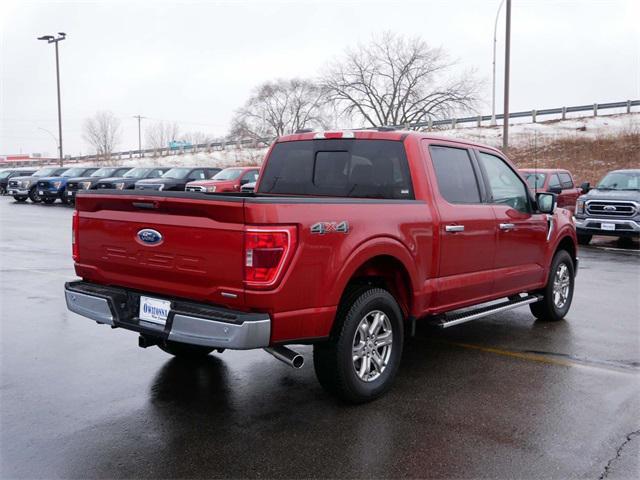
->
[[6, 100, 640, 163]]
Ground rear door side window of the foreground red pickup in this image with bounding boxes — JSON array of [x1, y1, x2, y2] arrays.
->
[[429, 145, 480, 203]]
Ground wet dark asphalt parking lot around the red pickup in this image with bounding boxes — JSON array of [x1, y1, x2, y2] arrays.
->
[[0, 197, 640, 479]]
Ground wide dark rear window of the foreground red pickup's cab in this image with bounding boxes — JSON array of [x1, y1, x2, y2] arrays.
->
[[258, 139, 414, 199]]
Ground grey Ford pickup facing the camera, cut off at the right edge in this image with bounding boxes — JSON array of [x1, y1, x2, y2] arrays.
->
[[575, 169, 640, 245]]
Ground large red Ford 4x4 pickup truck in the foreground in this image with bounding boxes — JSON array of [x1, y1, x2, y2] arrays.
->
[[65, 131, 578, 402]]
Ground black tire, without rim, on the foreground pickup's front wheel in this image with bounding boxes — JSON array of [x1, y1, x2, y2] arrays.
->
[[529, 250, 575, 322]]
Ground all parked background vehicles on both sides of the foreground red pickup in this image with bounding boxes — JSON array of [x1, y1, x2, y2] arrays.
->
[[0, 163, 640, 245]]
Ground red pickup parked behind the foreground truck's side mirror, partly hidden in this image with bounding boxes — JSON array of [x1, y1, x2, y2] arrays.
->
[[520, 168, 586, 213]]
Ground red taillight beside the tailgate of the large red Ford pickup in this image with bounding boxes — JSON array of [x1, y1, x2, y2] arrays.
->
[[244, 226, 297, 289]]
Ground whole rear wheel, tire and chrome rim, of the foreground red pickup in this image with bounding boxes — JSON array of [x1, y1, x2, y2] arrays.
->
[[313, 287, 404, 403]]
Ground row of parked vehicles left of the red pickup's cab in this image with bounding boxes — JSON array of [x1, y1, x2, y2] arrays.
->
[[0, 167, 259, 204]]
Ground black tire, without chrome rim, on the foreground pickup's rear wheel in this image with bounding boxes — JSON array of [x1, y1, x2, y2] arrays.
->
[[313, 287, 404, 403]]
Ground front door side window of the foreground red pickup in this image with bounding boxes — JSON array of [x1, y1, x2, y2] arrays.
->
[[480, 152, 529, 212]]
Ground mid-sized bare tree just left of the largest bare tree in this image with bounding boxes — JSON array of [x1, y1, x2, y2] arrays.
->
[[230, 79, 326, 140]]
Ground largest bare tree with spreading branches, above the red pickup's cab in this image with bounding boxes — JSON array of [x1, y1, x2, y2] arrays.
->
[[322, 32, 479, 127]]
